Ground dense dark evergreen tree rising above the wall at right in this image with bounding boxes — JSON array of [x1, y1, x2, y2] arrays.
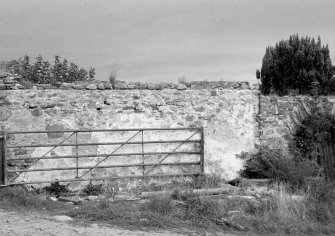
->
[[256, 34, 335, 95]]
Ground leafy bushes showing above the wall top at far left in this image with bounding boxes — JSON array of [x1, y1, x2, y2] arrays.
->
[[0, 55, 95, 84]]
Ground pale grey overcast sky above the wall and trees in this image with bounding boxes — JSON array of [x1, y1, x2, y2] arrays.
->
[[0, 0, 335, 83]]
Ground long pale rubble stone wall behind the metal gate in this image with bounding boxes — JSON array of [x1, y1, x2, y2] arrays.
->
[[0, 88, 259, 184]]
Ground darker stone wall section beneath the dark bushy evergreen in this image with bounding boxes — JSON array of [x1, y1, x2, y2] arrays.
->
[[259, 96, 335, 150]]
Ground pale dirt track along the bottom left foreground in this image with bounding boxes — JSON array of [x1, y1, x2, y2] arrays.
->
[[0, 209, 238, 236]]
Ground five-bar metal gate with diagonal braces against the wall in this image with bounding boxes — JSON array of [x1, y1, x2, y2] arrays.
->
[[0, 128, 204, 186]]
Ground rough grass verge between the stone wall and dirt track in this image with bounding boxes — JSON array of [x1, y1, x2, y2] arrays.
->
[[0, 177, 335, 235]]
